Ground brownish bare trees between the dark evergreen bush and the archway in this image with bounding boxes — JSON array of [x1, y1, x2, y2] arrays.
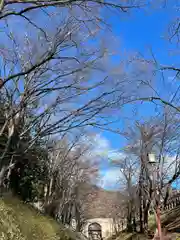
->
[[44, 135, 97, 231]]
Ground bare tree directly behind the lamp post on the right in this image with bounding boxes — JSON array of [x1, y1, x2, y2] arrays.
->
[[116, 109, 179, 231]]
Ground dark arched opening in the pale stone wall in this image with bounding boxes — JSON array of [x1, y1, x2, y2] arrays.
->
[[88, 222, 102, 240]]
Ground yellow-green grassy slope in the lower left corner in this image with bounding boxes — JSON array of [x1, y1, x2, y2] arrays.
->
[[0, 197, 77, 240]]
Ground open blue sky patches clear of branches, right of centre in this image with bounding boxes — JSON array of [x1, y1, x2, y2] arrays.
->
[[100, 5, 178, 189]]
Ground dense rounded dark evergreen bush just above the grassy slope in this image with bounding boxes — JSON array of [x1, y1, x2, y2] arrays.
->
[[9, 143, 47, 201]]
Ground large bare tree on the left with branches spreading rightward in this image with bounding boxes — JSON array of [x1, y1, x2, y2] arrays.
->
[[1, 11, 131, 190]]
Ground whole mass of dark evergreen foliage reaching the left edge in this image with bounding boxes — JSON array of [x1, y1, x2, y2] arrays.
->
[[0, 101, 47, 201]]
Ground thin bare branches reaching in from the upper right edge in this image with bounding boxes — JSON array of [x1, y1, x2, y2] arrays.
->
[[124, 0, 180, 115]]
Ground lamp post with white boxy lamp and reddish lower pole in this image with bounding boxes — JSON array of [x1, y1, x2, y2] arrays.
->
[[148, 153, 162, 240]]
